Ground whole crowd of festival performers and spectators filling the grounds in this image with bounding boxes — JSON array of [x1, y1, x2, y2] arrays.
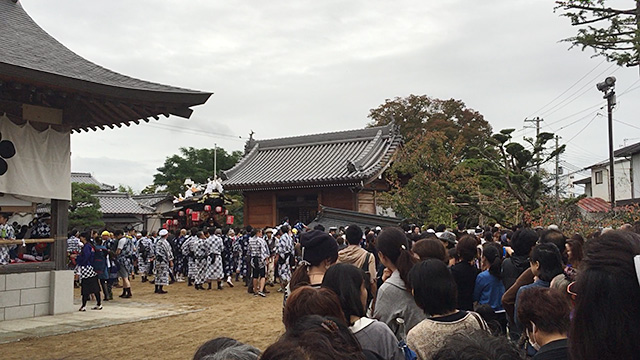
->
[[61, 221, 640, 360]]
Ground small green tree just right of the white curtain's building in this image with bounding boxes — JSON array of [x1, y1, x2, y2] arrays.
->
[[69, 182, 104, 229]]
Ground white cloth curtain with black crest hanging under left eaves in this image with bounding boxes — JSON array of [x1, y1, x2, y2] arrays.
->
[[0, 115, 71, 200]]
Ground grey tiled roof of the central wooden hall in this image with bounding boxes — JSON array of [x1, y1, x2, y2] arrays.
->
[[222, 124, 402, 190]]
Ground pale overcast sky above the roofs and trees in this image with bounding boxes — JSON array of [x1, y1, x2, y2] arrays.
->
[[21, 0, 640, 190]]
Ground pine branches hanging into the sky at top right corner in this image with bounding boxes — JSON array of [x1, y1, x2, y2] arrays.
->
[[556, 0, 640, 66]]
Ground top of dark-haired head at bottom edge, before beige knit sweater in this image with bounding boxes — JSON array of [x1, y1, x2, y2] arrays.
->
[[432, 330, 526, 360]]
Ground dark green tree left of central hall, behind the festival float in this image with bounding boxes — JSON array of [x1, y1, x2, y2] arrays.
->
[[153, 147, 242, 195]]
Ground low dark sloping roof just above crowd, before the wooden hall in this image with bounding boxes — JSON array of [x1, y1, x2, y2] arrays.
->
[[307, 206, 402, 230]]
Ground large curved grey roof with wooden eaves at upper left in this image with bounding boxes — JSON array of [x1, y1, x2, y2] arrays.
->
[[0, 0, 211, 131]]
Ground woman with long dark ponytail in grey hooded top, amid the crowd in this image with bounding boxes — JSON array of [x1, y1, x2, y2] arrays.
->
[[373, 227, 424, 340]]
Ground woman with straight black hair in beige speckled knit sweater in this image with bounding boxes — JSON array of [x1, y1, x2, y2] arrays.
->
[[407, 259, 487, 360]]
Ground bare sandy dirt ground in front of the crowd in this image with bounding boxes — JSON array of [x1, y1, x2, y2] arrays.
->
[[0, 276, 284, 359]]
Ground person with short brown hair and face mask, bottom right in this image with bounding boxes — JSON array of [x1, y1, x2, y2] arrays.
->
[[518, 287, 569, 360]]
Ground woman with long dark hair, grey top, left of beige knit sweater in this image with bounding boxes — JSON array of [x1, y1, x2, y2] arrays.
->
[[322, 263, 404, 360]]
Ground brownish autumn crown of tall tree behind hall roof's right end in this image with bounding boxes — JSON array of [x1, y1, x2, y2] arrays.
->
[[369, 94, 491, 157]]
